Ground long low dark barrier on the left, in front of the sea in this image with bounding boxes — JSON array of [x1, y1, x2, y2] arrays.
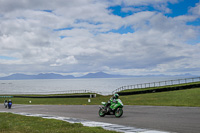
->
[[13, 94, 96, 98]]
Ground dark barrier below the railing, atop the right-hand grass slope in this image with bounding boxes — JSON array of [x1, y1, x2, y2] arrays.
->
[[118, 83, 200, 96]]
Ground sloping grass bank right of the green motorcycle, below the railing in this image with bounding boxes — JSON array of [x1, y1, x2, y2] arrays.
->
[[121, 88, 200, 107]]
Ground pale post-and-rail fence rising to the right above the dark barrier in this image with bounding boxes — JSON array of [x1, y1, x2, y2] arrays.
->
[[112, 77, 200, 94]]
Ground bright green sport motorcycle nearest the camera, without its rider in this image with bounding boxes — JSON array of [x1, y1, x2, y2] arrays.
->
[[99, 99, 123, 118]]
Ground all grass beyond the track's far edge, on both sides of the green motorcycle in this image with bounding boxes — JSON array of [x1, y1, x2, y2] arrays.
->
[[0, 88, 200, 107]]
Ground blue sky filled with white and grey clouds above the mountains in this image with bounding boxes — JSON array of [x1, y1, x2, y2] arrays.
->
[[0, 0, 200, 76]]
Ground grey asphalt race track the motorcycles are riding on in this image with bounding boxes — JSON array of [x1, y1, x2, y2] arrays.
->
[[0, 104, 200, 133]]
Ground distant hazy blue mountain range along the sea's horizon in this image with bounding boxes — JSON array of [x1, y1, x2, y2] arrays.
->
[[0, 72, 194, 80]]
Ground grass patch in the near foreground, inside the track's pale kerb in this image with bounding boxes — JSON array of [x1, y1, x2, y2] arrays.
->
[[0, 113, 116, 133]]
